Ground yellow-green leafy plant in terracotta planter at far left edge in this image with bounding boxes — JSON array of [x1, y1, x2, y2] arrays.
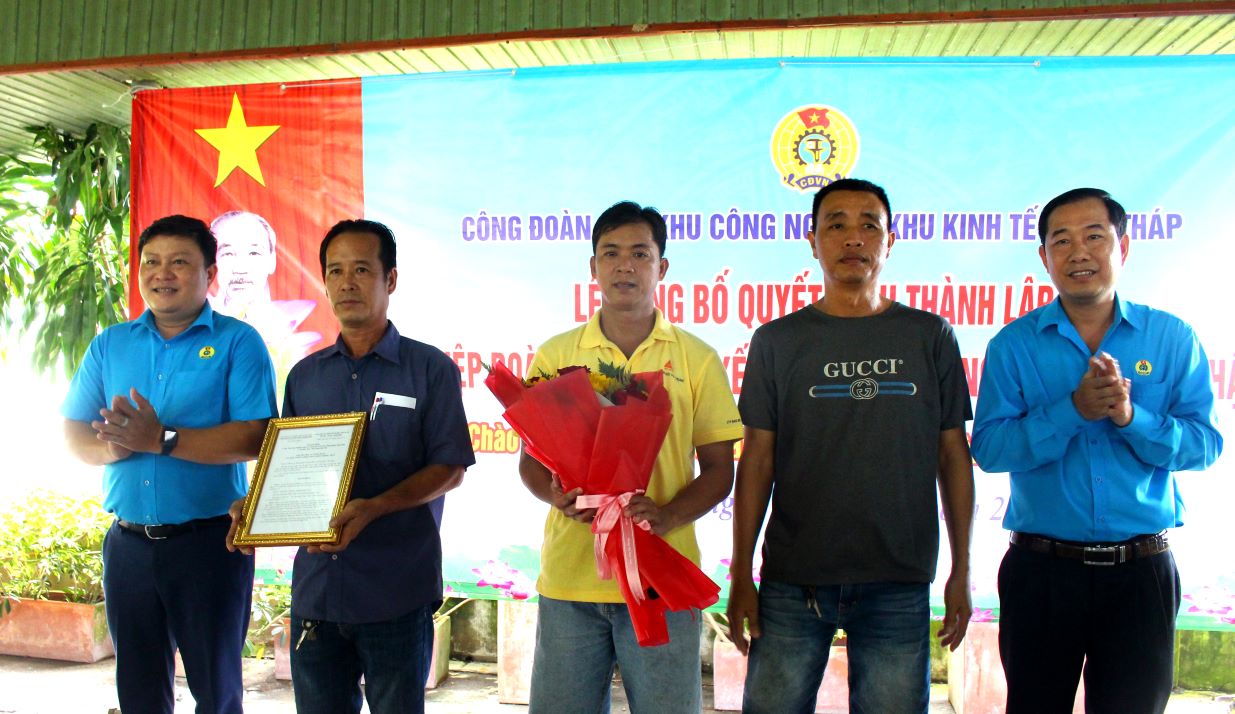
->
[[0, 490, 112, 662]]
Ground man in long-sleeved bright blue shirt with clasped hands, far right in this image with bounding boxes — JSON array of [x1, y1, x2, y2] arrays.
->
[[973, 188, 1223, 714]]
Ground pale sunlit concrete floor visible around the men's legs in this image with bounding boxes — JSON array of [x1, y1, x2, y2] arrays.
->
[[0, 656, 1235, 714]]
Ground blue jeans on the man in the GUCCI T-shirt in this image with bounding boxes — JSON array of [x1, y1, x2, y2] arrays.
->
[[742, 581, 930, 714]]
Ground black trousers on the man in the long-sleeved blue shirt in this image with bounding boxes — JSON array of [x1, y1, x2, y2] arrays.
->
[[999, 538, 1179, 714]]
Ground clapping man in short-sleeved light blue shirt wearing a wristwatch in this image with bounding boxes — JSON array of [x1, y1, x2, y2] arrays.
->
[[61, 216, 277, 714]]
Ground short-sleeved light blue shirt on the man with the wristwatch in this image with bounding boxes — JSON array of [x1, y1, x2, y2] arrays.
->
[[61, 304, 277, 524]]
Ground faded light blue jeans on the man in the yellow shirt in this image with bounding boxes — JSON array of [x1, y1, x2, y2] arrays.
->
[[529, 595, 703, 714]]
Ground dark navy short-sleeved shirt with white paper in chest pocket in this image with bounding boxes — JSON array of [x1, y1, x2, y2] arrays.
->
[[283, 322, 475, 624]]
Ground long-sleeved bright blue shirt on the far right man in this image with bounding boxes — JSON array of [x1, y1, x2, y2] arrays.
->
[[973, 295, 1223, 542]]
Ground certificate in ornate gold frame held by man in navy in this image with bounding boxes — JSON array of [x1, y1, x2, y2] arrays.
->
[[236, 411, 367, 546]]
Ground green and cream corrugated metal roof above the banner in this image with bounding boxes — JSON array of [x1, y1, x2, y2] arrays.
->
[[0, 0, 1235, 152]]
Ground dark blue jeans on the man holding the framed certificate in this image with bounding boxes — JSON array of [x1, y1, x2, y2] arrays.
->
[[291, 603, 437, 714]]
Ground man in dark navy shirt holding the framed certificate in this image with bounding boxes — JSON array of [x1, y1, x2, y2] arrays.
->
[[232, 220, 475, 714]]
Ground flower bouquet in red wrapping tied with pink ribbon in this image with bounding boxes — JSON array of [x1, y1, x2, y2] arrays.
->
[[484, 362, 720, 647]]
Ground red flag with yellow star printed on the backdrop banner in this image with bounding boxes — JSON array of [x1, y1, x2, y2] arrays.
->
[[130, 80, 364, 353]]
